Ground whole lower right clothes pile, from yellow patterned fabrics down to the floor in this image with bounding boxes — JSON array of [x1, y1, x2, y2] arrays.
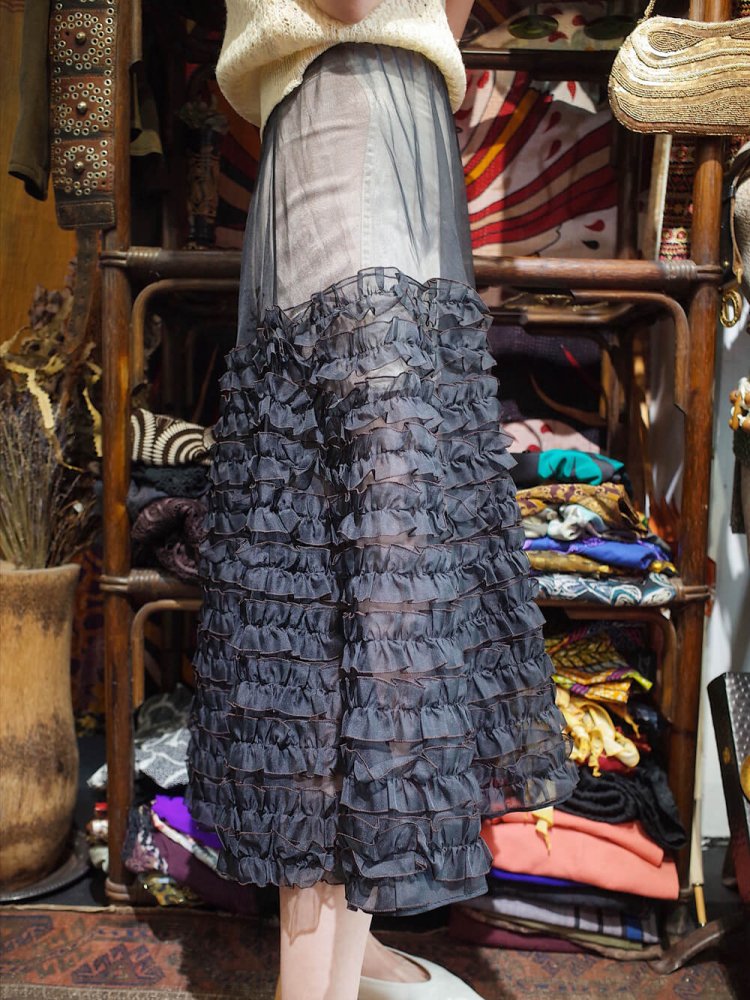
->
[[451, 615, 686, 959]]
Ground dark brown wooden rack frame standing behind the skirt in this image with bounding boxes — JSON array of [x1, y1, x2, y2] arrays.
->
[[91, 0, 730, 916]]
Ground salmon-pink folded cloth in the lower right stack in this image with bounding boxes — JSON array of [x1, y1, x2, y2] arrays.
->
[[482, 812, 679, 899]]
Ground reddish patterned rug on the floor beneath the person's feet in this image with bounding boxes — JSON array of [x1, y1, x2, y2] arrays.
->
[[0, 907, 742, 1000]]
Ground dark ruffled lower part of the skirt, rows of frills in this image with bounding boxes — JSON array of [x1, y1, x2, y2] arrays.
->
[[189, 268, 576, 914]]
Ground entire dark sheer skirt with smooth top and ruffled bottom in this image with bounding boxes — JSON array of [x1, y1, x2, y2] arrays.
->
[[189, 45, 575, 914]]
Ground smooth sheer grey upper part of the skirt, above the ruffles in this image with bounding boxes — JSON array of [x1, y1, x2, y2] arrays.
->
[[238, 45, 473, 345]]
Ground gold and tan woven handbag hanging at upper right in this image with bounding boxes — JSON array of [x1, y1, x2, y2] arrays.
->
[[609, 0, 750, 135]]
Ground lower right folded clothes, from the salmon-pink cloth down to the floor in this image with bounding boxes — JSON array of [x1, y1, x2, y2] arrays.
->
[[450, 810, 678, 960]]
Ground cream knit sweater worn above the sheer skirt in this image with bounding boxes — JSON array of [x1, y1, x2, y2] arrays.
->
[[216, 0, 466, 128]]
